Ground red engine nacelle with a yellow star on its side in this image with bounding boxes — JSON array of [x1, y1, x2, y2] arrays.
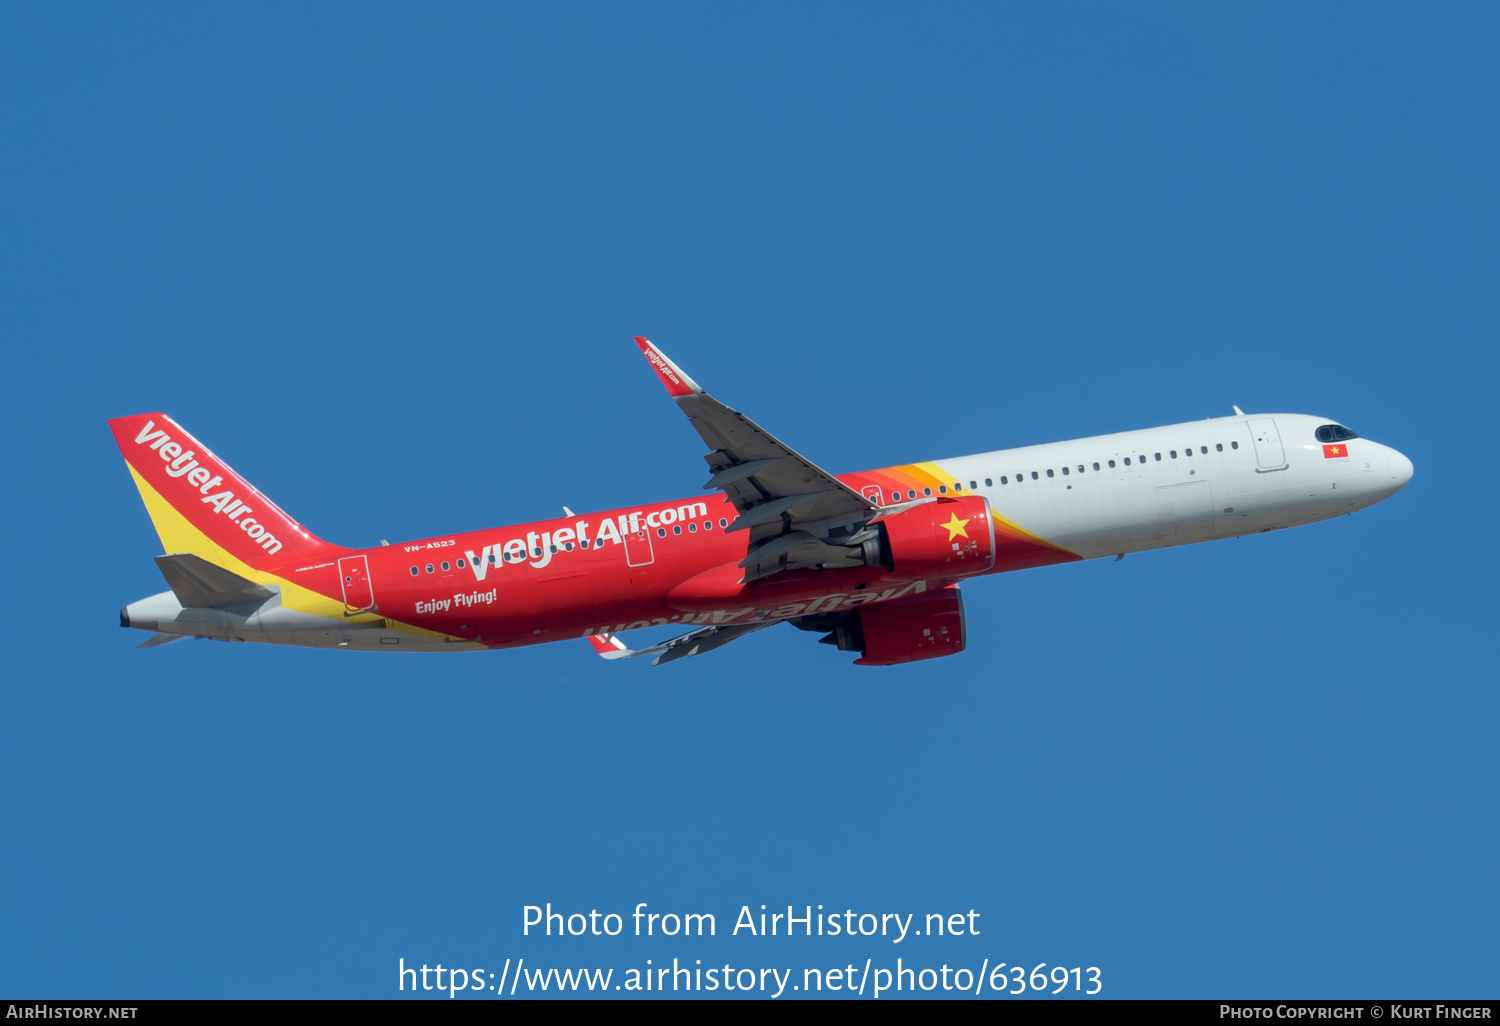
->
[[878, 495, 995, 579]]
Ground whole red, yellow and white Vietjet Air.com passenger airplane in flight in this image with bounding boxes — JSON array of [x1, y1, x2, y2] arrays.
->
[[110, 338, 1412, 666]]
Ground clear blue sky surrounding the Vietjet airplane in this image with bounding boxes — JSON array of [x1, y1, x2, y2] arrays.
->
[[0, 5, 1500, 998]]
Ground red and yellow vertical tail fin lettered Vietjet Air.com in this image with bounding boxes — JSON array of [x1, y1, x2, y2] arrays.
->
[[110, 413, 339, 572]]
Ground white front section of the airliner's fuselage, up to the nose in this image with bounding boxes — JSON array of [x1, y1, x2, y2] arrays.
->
[[936, 414, 1412, 560]]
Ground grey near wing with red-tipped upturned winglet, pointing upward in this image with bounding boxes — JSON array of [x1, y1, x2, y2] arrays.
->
[[636, 336, 881, 584]]
